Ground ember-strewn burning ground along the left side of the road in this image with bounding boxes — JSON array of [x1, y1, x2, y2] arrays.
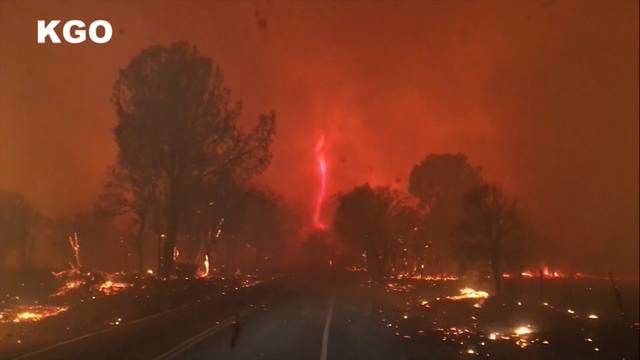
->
[[0, 270, 272, 358]]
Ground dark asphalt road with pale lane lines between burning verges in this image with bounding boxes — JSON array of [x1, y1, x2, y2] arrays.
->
[[10, 277, 404, 360]]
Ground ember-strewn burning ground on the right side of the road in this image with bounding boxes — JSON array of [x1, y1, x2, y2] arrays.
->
[[378, 272, 639, 359]]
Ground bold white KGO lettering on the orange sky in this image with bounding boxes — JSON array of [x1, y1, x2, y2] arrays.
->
[[38, 20, 113, 44]]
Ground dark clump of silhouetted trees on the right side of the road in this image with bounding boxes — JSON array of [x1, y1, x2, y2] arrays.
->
[[333, 154, 532, 292]]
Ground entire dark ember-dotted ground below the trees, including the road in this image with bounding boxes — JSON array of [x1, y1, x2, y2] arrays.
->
[[0, 272, 638, 359]]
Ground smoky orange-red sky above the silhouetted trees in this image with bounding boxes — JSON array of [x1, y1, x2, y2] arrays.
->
[[0, 0, 639, 273]]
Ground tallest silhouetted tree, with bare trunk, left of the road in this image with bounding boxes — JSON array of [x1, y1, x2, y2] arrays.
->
[[113, 42, 275, 276]]
